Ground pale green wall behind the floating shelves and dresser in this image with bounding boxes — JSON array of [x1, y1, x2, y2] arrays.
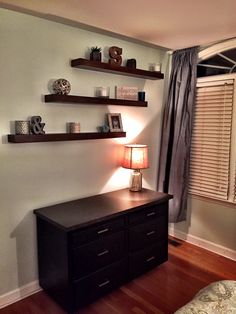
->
[[0, 9, 164, 295]]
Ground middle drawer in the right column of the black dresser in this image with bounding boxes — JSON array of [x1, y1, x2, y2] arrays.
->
[[129, 216, 168, 251]]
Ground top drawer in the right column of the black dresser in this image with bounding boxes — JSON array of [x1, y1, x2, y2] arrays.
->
[[128, 203, 168, 224]]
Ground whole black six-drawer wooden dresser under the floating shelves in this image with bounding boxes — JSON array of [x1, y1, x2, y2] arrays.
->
[[34, 189, 171, 313]]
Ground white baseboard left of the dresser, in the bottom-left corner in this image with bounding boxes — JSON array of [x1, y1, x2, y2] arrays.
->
[[0, 280, 42, 309]]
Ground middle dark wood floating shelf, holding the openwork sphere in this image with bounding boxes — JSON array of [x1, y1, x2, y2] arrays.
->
[[44, 94, 148, 107]]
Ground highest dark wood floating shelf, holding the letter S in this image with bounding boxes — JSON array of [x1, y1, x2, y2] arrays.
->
[[71, 58, 164, 80]]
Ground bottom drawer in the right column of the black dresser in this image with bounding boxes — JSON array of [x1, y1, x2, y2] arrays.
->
[[129, 240, 168, 278]]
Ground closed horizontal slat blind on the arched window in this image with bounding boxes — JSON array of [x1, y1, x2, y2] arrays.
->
[[189, 80, 233, 200]]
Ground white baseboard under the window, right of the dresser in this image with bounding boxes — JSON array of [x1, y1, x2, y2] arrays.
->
[[169, 227, 236, 261]]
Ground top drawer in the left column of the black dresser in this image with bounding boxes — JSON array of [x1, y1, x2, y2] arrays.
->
[[71, 217, 124, 247]]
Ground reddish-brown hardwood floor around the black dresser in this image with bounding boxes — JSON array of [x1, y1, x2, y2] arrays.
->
[[0, 240, 236, 314]]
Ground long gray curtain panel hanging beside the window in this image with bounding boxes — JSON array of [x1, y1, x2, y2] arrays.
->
[[158, 47, 198, 222]]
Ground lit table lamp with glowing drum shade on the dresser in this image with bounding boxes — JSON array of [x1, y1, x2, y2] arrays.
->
[[122, 144, 148, 192]]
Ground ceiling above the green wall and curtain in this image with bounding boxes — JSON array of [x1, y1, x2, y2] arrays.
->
[[0, 0, 236, 49]]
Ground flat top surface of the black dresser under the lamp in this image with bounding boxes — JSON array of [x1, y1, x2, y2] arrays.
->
[[34, 189, 172, 231]]
